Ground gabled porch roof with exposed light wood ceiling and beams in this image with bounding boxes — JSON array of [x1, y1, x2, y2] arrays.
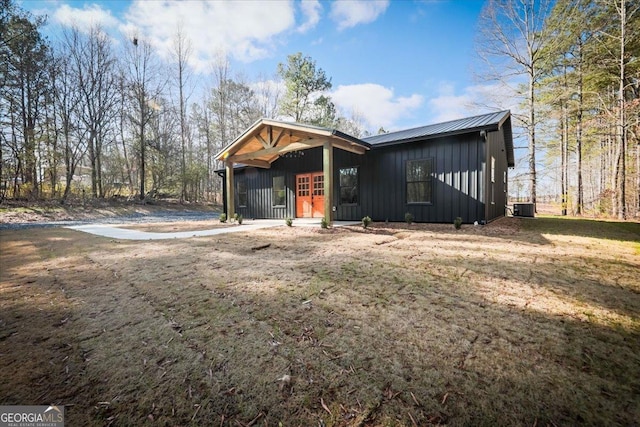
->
[[215, 119, 371, 168]]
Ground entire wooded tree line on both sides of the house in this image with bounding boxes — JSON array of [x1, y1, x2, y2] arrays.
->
[[0, 0, 640, 218]]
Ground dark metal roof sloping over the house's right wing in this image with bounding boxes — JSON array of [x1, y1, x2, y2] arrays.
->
[[362, 110, 515, 167]]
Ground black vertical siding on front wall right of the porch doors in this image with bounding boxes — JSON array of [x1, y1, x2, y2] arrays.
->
[[334, 134, 484, 222]]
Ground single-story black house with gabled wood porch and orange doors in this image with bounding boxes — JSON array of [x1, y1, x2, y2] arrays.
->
[[216, 111, 514, 224]]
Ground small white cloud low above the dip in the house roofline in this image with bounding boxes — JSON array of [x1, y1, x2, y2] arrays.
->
[[331, 83, 423, 129]]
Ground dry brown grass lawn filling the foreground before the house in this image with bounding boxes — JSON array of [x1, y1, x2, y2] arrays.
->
[[0, 218, 640, 426]]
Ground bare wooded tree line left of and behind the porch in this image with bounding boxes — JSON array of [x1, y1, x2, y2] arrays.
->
[[0, 0, 363, 202]]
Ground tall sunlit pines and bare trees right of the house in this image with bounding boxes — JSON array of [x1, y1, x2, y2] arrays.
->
[[478, 0, 640, 218]]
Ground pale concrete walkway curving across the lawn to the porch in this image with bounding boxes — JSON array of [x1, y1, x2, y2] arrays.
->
[[65, 218, 359, 240]]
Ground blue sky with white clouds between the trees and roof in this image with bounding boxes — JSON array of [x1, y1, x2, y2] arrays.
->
[[21, 0, 504, 132]]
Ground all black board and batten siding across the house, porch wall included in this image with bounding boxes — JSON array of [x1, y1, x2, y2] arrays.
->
[[228, 132, 498, 223]]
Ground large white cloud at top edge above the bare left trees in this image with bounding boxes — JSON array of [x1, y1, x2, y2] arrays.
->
[[122, 0, 295, 72]]
